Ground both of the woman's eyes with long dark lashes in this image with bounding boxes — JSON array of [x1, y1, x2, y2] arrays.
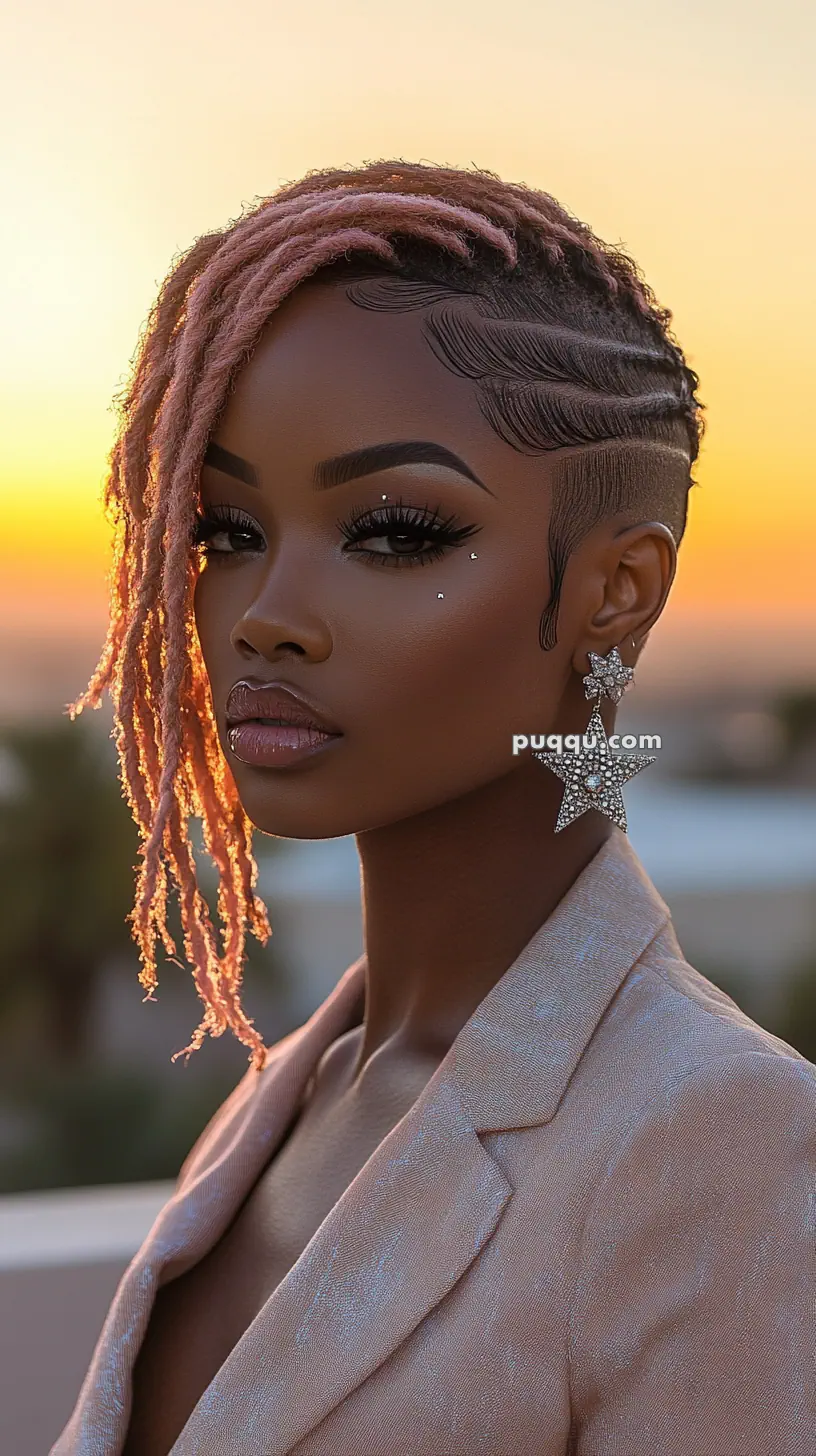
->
[[191, 501, 481, 566]]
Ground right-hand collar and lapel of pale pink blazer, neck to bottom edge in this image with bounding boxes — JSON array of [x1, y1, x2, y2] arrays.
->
[[170, 830, 669, 1456]]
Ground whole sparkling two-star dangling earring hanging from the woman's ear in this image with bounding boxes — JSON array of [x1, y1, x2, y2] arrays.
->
[[535, 638, 656, 833]]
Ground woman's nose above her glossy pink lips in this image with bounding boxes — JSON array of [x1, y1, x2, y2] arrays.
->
[[230, 562, 332, 662]]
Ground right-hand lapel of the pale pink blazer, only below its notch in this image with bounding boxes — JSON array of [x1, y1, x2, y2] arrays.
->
[[170, 1067, 513, 1456]]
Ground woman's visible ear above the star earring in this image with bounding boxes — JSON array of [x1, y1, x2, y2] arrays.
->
[[573, 521, 678, 673]]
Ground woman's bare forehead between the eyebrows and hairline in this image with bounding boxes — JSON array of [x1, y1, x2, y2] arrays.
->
[[217, 282, 512, 470]]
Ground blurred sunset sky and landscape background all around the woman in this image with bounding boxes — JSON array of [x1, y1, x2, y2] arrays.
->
[[0, 0, 816, 1456]]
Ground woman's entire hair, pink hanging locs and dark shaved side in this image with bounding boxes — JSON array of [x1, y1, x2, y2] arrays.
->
[[67, 160, 702, 1069]]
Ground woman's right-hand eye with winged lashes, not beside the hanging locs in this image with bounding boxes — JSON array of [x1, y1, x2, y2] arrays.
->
[[337, 501, 481, 566]]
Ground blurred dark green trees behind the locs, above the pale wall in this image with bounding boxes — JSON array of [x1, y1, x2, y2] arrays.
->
[[0, 709, 300, 1194]]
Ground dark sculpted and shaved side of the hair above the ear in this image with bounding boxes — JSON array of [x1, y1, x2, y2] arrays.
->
[[332, 224, 702, 651]]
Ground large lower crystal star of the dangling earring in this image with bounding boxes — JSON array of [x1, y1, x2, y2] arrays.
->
[[533, 701, 656, 833]]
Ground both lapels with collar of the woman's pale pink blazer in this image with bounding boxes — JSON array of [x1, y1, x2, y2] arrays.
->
[[52, 828, 669, 1456]]
